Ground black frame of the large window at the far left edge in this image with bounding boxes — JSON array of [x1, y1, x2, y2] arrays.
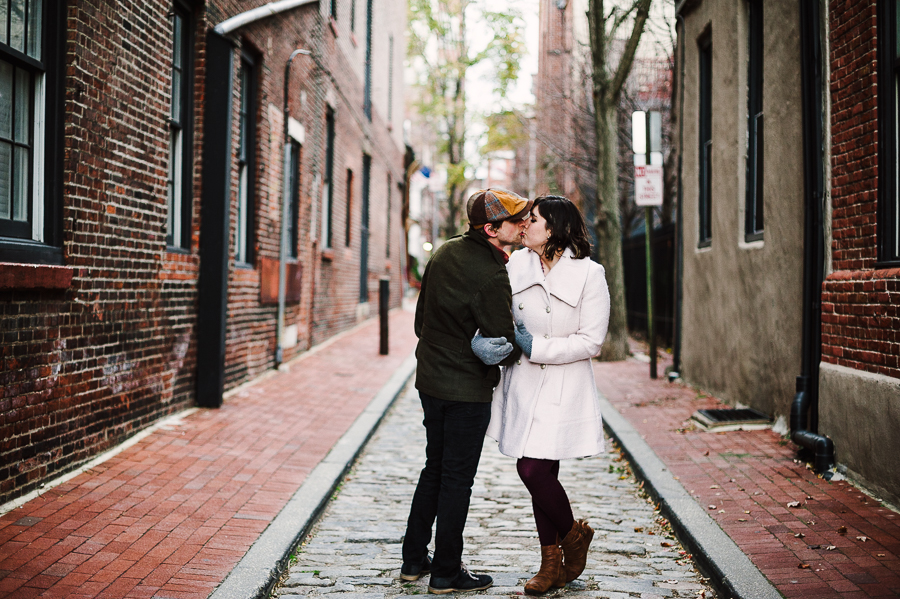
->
[[0, 0, 67, 265]]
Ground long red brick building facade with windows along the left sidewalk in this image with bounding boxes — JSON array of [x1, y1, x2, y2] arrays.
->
[[0, 0, 406, 503]]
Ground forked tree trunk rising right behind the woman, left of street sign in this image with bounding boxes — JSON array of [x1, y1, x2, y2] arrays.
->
[[588, 0, 652, 360]]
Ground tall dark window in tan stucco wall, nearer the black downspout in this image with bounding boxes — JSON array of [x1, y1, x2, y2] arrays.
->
[[744, 0, 765, 242]]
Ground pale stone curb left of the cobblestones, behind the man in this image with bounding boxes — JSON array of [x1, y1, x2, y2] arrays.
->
[[209, 353, 416, 599]]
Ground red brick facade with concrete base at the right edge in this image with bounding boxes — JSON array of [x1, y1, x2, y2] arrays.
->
[[819, 0, 900, 504]]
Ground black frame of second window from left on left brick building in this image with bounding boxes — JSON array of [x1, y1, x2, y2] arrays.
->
[[166, 0, 196, 253]]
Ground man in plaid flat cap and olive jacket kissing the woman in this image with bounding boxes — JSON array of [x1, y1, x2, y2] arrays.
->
[[400, 189, 533, 594]]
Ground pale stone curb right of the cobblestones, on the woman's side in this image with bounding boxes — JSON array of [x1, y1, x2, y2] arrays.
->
[[598, 391, 783, 599]]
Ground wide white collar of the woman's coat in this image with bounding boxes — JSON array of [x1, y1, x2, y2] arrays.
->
[[506, 248, 591, 308]]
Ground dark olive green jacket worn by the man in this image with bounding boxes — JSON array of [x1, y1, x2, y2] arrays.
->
[[415, 229, 522, 402]]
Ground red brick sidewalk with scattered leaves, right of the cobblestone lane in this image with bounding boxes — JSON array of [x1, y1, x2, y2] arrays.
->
[[594, 352, 900, 599]]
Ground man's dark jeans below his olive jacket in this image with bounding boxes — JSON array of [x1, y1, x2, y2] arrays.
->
[[403, 392, 491, 578]]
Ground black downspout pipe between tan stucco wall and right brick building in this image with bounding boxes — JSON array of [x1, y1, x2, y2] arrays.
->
[[791, 0, 834, 476]]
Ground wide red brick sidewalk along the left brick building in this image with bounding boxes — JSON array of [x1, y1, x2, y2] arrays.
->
[[0, 310, 416, 599]]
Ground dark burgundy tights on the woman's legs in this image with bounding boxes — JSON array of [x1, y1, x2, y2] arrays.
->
[[516, 458, 575, 545]]
